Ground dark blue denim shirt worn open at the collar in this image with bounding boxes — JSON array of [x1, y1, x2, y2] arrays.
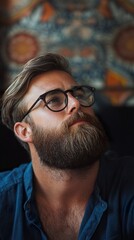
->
[[0, 153, 134, 240]]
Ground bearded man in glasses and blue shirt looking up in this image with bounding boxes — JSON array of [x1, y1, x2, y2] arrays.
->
[[0, 53, 134, 240]]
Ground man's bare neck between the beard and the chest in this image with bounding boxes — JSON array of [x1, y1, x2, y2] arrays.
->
[[33, 161, 99, 208]]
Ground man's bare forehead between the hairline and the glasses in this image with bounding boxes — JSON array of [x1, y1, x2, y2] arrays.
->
[[25, 70, 78, 104]]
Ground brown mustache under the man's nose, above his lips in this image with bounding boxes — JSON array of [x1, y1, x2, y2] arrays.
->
[[62, 112, 102, 129]]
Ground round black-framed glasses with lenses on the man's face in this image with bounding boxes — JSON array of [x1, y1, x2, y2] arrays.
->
[[21, 86, 95, 121]]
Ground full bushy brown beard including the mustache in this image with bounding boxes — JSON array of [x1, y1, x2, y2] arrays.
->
[[30, 112, 108, 170]]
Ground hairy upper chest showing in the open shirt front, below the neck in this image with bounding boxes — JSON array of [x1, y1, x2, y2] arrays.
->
[[38, 204, 84, 240]]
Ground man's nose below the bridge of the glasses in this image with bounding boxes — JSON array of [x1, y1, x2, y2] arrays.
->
[[67, 93, 80, 113]]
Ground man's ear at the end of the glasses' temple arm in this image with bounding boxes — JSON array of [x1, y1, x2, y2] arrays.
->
[[14, 122, 32, 143]]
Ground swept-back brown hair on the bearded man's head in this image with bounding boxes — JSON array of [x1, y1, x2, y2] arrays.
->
[[1, 53, 71, 150]]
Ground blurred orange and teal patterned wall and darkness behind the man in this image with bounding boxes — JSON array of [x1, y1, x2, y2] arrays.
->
[[0, 0, 134, 171]]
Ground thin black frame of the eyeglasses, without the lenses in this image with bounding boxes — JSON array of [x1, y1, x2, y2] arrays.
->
[[20, 85, 95, 122]]
